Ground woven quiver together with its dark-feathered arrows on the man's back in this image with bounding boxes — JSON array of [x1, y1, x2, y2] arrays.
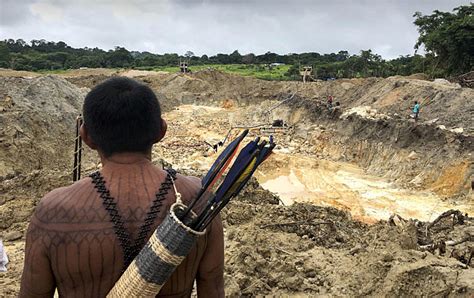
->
[[107, 130, 275, 297]]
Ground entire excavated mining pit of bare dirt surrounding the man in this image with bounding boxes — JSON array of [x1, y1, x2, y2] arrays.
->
[[0, 70, 474, 297]]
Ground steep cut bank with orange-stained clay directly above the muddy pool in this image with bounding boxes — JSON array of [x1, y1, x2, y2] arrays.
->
[[278, 95, 474, 197]]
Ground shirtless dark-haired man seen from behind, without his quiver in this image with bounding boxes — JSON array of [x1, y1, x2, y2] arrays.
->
[[20, 78, 224, 297]]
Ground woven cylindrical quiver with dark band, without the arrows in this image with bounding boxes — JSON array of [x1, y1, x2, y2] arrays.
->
[[107, 203, 205, 297]]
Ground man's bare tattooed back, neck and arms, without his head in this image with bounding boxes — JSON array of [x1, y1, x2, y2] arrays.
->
[[20, 159, 223, 297]]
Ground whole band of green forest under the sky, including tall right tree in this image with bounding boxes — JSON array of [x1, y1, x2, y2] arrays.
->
[[0, 4, 474, 80]]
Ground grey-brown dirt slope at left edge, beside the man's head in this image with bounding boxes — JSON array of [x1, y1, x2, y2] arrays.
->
[[0, 76, 86, 177]]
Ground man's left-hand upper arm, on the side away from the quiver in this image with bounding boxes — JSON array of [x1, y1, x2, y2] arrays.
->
[[19, 215, 56, 297]]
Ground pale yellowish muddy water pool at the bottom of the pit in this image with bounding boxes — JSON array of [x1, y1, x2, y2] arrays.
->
[[256, 153, 474, 222]]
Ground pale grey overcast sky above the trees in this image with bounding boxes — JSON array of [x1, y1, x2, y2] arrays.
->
[[0, 0, 470, 59]]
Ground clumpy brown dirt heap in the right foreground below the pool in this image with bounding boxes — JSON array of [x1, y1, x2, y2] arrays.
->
[[224, 194, 474, 297]]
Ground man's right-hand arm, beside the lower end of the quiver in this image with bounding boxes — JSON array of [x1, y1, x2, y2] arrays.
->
[[196, 215, 224, 297]]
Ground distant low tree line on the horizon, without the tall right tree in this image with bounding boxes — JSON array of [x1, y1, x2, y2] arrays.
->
[[0, 39, 434, 79]]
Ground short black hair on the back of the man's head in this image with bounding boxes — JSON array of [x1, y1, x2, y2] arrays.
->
[[83, 77, 161, 156]]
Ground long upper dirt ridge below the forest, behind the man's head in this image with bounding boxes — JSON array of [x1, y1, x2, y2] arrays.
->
[[65, 70, 474, 132]]
